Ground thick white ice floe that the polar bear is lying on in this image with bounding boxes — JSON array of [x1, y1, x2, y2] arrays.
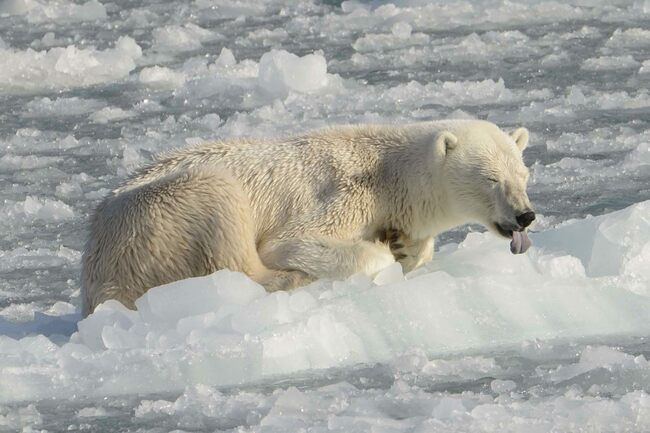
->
[[0, 201, 650, 402]]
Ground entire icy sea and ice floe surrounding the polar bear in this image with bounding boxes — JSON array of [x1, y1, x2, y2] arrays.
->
[[0, 0, 650, 432]]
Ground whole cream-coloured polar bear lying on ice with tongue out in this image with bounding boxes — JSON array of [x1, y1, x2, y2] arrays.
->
[[82, 120, 535, 316]]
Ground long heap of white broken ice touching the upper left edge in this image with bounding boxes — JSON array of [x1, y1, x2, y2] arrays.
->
[[0, 36, 142, 92]]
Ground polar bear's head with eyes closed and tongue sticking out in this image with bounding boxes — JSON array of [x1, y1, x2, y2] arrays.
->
[[434, 121, 535, 253]]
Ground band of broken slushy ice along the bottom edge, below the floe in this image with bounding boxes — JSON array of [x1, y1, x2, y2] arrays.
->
[[130, 372, 650, 432]]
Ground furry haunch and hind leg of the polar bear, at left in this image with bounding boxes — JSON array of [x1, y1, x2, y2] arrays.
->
[[82, 167, 312, 316]]
